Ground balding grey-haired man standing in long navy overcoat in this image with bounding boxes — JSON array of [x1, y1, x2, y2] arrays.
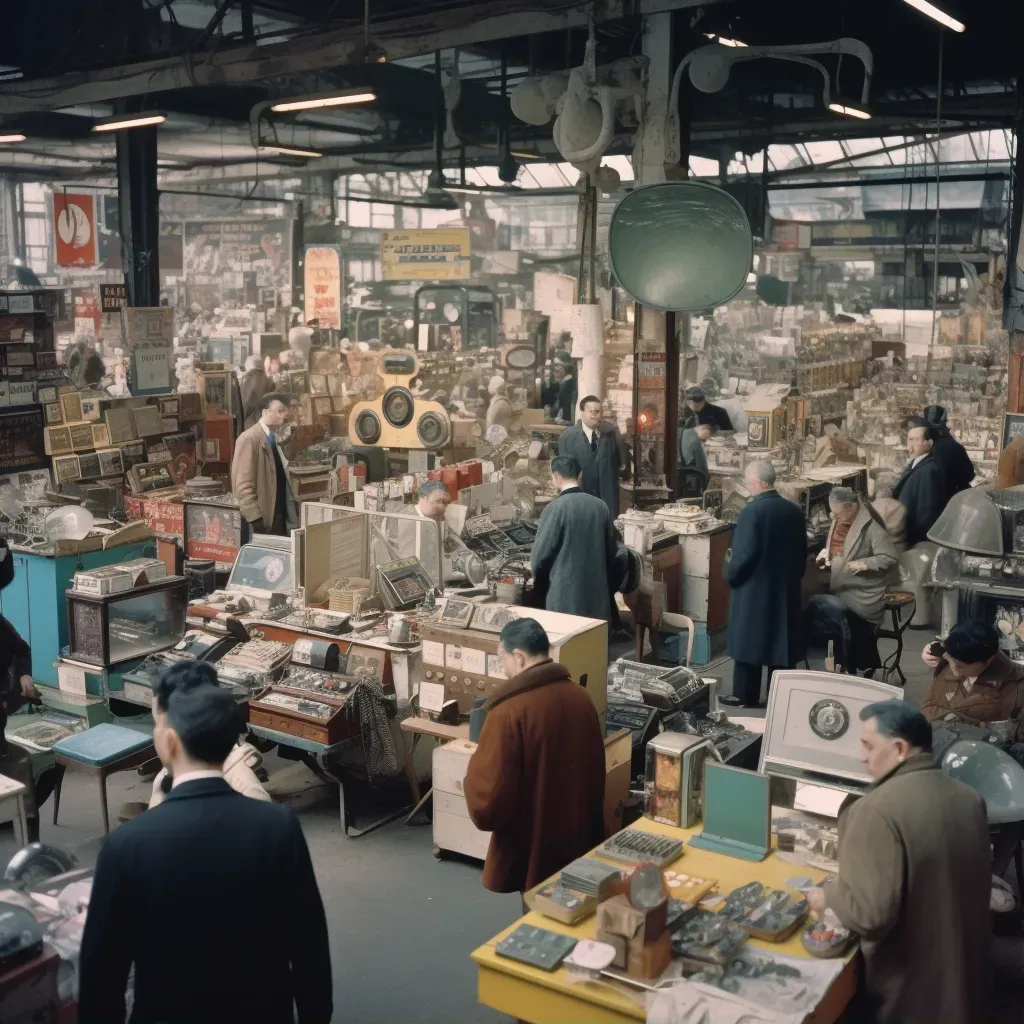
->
[[722, 461, 807, 708]]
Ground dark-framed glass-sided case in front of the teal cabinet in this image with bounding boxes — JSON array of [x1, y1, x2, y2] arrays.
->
[[67, 577, 188, 668]]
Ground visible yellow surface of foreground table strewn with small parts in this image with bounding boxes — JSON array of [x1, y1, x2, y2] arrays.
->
[[472, 818, 858, 1024]]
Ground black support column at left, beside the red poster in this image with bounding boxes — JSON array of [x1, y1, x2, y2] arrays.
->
[[115, 103, 160, 306]]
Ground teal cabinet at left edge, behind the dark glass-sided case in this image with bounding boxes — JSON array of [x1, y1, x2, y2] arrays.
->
[[0, 542, 153, 686]]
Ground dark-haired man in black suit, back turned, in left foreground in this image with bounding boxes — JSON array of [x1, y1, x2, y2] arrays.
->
[[78, 664, 332, 1024]]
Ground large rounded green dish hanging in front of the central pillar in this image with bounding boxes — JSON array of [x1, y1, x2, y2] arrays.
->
[[608, 181, 754, 312]]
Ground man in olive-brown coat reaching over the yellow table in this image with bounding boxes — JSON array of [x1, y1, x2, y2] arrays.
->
[[807, 700, 992, 1024]]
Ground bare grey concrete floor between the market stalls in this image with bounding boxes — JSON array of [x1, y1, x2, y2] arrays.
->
[[0, 631, 1024, 1024]]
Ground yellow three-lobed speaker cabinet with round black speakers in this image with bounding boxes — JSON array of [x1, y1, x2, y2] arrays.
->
[[348, 351, 452, 449]]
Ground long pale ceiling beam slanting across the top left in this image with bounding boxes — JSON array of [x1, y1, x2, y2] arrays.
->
[[0, 0, 708, 114]]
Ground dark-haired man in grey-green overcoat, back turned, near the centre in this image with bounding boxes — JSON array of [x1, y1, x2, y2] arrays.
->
[[530, 456, 616, 622]]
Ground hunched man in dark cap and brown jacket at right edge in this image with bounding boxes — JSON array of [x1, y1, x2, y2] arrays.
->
[[921, 620, 1024, 742]]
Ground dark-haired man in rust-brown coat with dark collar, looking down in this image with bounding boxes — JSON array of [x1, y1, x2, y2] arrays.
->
[[464, 618, 604, 893]]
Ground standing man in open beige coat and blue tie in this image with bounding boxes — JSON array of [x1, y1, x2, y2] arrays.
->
[[231, 392, 299, 537]]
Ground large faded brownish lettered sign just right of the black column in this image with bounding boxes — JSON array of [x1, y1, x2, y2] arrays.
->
[[182, 219, 292, 309]]
